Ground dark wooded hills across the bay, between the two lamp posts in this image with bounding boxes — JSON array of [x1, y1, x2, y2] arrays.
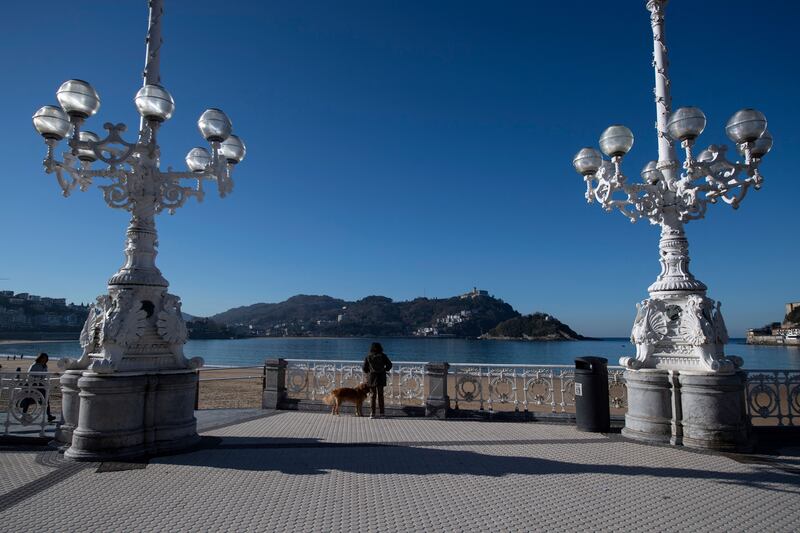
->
[[203, 288, 583, 340]]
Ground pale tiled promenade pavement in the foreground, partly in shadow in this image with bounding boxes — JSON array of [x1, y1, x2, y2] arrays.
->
[[0, 411, 800, 532]]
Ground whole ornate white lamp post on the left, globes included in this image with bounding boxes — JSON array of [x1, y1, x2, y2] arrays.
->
[[33, 0, 245, 460]]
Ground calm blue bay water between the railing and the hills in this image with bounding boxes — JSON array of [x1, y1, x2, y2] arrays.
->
[[0, 337, 800, 370]]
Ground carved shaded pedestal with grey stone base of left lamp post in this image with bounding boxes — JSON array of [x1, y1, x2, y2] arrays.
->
[[56, 210, 203, 461]]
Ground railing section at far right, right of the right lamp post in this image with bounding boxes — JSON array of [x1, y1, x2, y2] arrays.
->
[[746, 370, 800, 426]]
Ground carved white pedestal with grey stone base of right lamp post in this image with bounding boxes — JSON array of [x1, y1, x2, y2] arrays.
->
[[620, 213, 751, 451]]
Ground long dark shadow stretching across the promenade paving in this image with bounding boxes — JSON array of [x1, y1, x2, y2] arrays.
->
[[152, 437, 800, 495]]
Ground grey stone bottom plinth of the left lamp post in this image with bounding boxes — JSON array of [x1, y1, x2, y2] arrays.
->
[[64, 370, 200, 461]]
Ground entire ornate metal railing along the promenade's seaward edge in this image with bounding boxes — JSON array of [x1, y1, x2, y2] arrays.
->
[[0, 359, 800, 428]]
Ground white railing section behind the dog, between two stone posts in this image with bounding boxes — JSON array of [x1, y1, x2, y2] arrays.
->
[[286, 359, 426, 405]]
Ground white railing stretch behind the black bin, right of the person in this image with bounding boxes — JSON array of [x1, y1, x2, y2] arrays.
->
[[449, 363, 628, 413]]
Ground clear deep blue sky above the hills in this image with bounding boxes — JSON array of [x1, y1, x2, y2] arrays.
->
[[0, 0, 800, 336]]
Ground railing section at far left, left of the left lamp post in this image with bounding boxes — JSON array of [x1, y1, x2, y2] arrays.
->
[[0, 372, 58, 436]]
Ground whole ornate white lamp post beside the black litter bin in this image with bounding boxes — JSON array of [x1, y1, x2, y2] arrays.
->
[[573, 0, 772, 449]]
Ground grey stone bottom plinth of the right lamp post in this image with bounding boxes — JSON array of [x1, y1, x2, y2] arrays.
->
[[622, 369, 753, 452]]
